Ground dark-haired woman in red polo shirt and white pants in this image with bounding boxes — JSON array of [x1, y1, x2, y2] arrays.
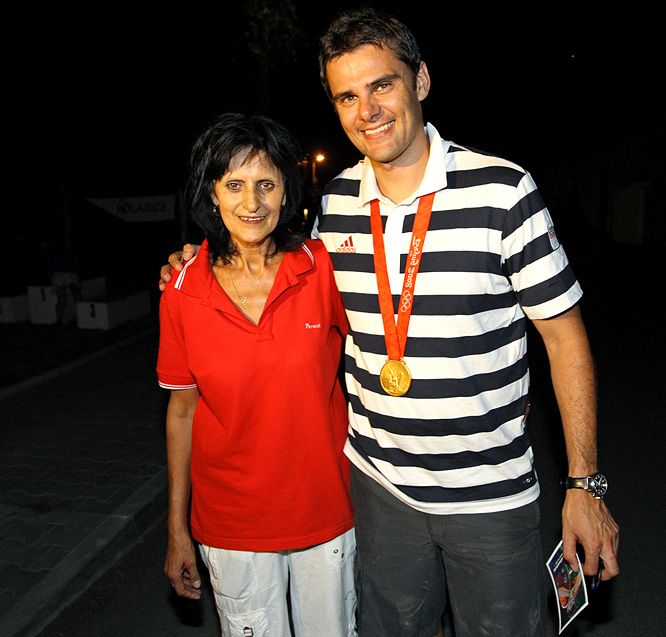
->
[[157, 114, 356, 637]]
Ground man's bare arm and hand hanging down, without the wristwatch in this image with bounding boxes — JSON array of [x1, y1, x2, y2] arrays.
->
[[534, 306, 620, 580]]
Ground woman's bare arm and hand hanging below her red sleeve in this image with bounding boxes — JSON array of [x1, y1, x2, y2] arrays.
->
[[164, 389, 201, 599]]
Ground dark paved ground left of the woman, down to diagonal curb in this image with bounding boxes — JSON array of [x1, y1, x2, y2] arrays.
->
[[0, 316, 166, 637]]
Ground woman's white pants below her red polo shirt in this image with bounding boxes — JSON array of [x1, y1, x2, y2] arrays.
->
[[200, 529, 356, 637]]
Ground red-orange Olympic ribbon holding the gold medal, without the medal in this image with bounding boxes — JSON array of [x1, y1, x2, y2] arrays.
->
[[370, 192, 435, 360]]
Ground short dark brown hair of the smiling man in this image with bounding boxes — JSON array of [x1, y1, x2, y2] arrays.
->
[[319, 7, 421, 99]]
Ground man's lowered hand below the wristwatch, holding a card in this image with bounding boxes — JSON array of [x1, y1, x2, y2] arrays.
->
[[562, 489, 620, 580]]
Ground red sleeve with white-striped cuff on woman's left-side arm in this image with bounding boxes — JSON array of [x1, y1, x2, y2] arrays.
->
[[157, 285, 197, 389]]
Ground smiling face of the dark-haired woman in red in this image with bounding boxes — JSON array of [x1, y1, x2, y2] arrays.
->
[[213, 151, 286, 249]]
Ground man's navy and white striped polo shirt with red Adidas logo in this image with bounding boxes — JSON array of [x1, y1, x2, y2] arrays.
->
[[313, 124, 582, 514]]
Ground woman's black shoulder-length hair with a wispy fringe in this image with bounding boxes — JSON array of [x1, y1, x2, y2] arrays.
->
[[185, 113, 303, 262]]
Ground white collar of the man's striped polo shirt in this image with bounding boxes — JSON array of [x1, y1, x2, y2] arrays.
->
[[359, 123, 449, 206]]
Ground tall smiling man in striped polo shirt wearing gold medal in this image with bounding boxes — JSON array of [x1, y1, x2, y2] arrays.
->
[[162, 9, 619, 637]]
